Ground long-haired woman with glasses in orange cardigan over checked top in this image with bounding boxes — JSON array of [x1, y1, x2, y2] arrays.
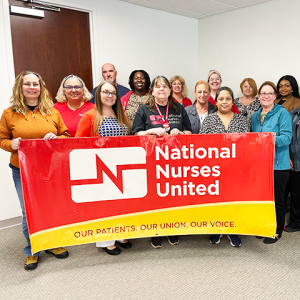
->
[[75, 81, 132, 255]]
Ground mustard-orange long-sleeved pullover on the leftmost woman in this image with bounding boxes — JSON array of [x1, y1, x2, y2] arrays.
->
[[0, 107, 69, 168]]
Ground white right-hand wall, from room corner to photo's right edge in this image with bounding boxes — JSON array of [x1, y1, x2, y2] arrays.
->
[[198, 0, 300, 96]]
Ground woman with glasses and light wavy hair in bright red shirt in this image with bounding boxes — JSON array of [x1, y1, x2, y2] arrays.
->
[[53, 74, 94, 137]]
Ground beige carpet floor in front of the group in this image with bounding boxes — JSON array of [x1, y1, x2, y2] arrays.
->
[[0, 225, 300, 300]]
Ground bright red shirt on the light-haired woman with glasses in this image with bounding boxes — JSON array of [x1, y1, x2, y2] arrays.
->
[[53, 102, 94, 137]]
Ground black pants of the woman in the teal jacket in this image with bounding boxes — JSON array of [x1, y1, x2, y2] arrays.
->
[[274, 170, 290, 234]]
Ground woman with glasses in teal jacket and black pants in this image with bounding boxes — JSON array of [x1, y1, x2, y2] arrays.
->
[[251, 81, 292, 244]]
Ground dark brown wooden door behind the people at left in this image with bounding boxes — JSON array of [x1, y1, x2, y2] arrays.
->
[[9, 0, 93, 98]]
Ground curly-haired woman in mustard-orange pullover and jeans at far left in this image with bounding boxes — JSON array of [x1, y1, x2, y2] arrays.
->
[[0, 71, 69, 270]]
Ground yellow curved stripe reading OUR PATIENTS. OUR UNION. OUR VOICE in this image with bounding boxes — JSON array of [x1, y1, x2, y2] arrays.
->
[[30, 201, 276, 252]]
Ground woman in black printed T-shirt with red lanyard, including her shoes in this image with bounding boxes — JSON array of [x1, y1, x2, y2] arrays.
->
[[131, 76, 192, 248]]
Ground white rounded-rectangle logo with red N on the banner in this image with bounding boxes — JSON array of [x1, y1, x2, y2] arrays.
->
[[69, 147, 147, 203]]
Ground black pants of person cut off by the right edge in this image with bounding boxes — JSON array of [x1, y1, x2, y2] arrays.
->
[[289, 171, 300, 228]]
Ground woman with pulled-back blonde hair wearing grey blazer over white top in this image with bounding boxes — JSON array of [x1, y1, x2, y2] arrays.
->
[[185, 80, 215, 134]]
